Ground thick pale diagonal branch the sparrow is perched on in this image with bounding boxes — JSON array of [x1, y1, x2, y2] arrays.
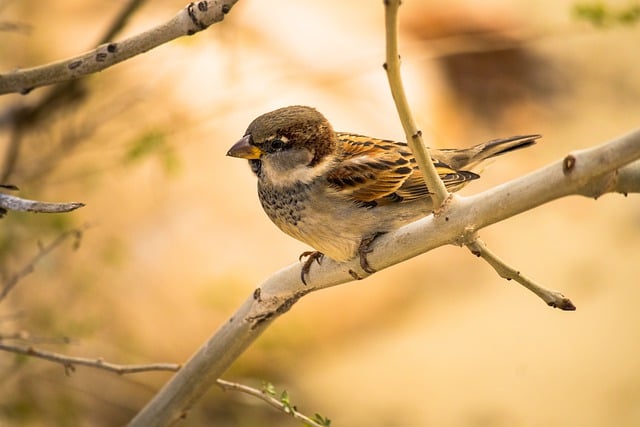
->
[[130, 130, 640, 426]]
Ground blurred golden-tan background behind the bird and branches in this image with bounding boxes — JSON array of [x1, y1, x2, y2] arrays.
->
[[0, 0, 640, 427]]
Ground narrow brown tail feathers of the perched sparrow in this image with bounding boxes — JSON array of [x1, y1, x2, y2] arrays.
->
[[434, 135, 541, 170]]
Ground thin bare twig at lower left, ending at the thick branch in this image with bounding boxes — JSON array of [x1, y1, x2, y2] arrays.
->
[[0, 342, 181, 375]]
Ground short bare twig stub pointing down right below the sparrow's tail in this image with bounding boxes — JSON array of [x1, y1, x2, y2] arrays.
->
[[466, 236, 576, 311]]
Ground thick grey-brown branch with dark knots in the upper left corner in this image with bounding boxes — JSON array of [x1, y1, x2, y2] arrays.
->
[[0, 0, 238, 94]]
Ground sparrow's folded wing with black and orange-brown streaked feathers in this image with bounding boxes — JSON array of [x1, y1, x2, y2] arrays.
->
[[327, 133, 478, 206]]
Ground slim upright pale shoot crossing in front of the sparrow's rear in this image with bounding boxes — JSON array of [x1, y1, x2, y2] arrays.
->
[[384, 0, 449, 211]]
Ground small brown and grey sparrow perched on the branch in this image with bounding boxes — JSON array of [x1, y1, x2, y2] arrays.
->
[[227, 105, 540, 285]]
